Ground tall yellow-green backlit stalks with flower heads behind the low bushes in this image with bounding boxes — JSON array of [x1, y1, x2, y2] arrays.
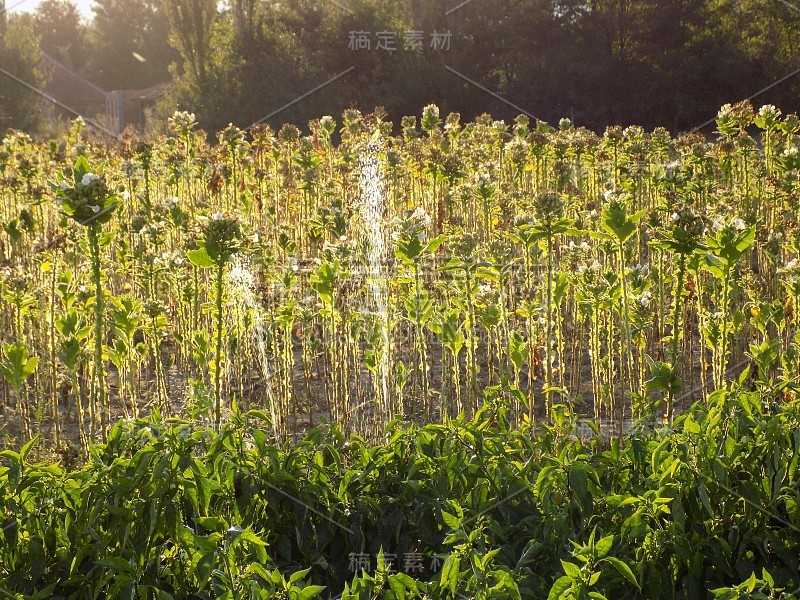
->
[[0, 103, 800, 448]]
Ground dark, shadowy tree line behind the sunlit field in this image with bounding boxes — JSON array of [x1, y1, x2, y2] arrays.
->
[[0, 0, 800, 132]]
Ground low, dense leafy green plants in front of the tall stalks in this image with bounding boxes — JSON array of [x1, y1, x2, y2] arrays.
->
[[0, 377, 800, 600]]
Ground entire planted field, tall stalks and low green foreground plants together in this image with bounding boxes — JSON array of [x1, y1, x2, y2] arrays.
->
[[0, 102, 800, 600]]
